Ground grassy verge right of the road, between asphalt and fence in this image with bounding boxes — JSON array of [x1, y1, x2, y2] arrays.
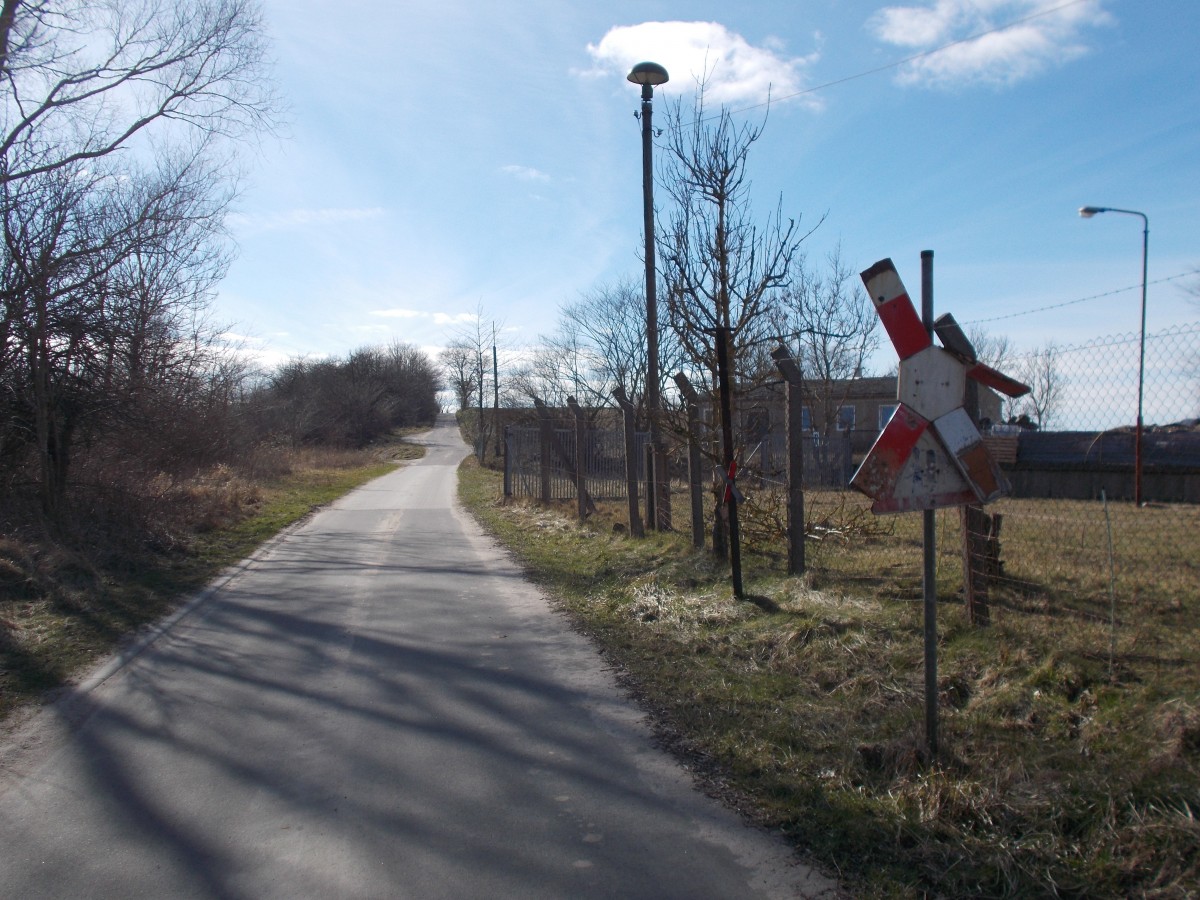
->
[[461, 461, 1200, 898]]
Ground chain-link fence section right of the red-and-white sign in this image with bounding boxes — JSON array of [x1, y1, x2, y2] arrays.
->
[[947, 323, 1200, 638]]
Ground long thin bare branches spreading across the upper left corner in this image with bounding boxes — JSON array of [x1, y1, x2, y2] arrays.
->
[[0, 0, 277, 182]]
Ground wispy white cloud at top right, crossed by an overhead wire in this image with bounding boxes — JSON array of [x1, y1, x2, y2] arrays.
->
[[866, 0, 1112, 88]]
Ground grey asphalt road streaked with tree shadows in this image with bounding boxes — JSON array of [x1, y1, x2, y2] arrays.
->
[[0, 425, 835, 900]]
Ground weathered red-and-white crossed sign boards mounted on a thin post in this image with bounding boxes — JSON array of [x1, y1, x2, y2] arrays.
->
[[850, 259, 1030, 514]]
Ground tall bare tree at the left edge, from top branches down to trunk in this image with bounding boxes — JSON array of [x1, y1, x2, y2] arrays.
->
[[0, 0, 274, 522]]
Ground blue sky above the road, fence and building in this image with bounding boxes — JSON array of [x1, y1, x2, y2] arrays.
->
[[216, 0, 1200, 420]]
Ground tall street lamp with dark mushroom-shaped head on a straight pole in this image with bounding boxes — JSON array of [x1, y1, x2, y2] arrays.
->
[[628, 62, 671, 530]]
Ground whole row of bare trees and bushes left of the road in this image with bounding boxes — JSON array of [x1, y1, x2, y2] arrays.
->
[[0, 0, 437, 549]]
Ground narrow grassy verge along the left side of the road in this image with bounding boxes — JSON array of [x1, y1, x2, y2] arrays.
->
[[0, 439, 424, 719]]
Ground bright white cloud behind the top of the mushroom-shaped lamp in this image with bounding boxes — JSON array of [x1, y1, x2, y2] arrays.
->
[[580, 22, 820, 107]]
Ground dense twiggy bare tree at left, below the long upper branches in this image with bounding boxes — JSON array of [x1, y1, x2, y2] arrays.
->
[[0, 146, 238, 518]]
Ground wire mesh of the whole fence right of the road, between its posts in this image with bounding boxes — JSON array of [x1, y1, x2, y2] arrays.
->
[[508, 323, 1200, 638]]
